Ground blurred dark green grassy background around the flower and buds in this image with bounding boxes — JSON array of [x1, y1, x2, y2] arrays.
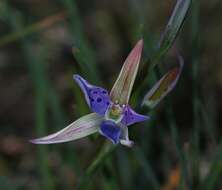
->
[[0, 0, 222, 190]]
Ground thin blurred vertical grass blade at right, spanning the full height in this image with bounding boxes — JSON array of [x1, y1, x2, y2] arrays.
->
[[190, 0, 202, 189]]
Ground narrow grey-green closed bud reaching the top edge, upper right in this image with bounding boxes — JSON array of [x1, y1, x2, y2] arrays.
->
[[158, 0, 191, 56]]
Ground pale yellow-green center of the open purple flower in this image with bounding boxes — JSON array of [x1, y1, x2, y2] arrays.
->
[[105, 103, 124, 123]]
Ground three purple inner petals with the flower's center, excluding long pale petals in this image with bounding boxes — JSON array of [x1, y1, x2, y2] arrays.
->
[[74, 75, 149, 145]]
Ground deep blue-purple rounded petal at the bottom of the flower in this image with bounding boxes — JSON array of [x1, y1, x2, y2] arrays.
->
[[99, 120, 121, 144]]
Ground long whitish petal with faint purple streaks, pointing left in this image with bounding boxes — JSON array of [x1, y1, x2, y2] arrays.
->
[[30, 113, 103, 144]]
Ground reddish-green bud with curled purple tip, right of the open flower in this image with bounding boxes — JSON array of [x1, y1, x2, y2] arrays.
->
[[142, 56, 184, 108]]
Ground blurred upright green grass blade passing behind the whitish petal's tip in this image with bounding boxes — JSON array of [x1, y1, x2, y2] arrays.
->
[[3, 6, 54, 190]]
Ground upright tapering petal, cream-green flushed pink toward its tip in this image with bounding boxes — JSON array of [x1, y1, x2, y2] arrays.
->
[[110, 40, 143, 104]]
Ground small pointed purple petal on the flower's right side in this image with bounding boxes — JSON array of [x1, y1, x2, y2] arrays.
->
[[121, 106, 149, 126]]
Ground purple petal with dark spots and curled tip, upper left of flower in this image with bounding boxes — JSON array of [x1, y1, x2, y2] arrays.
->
[[73, 75, 110, 115]]
